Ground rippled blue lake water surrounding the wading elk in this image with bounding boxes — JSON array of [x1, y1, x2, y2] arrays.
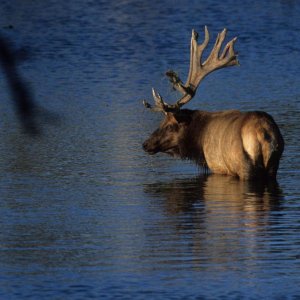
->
[[0, 0, 300, 300]]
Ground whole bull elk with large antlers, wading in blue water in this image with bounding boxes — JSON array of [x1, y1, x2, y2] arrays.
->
[[143, 26, 284, 180]]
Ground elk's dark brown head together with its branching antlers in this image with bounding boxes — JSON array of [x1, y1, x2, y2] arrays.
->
[[143, 26, 239, 158]]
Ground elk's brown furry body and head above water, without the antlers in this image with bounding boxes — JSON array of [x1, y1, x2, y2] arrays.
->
[[143, 109, 284, 179]]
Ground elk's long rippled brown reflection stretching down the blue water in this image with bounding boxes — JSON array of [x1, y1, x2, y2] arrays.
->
[[145, 174, 282, 266]]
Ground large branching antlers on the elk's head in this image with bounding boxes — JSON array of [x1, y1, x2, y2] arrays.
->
[[143, 26, 239, 113]]
